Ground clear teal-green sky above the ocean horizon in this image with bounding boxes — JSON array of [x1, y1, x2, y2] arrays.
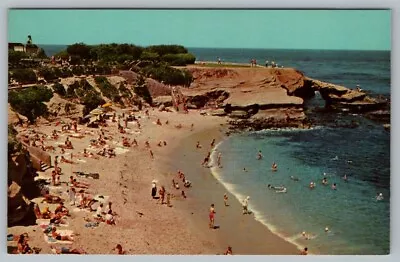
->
[[8, 10, 391, 50]]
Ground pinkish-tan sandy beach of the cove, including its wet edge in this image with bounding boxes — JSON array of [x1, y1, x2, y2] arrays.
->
[[8, 105, 298, 254]]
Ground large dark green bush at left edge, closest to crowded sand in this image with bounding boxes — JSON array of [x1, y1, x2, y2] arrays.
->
[[8, 86, 53, 123]]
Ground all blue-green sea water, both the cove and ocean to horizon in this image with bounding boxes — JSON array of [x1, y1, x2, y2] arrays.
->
[[41, 46, 390, 254]]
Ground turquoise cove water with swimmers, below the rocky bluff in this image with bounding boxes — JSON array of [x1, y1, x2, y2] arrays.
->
[[212, 125, 390, 254]]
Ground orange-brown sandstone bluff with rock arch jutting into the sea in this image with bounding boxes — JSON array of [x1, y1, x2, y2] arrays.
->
[[182, 65, 387, 129]]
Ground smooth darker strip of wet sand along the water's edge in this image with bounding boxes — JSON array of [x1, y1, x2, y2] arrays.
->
[[162, 124, 300, 255]]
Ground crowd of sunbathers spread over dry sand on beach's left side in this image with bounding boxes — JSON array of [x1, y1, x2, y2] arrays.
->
[[10, 108, 173, 254]]
